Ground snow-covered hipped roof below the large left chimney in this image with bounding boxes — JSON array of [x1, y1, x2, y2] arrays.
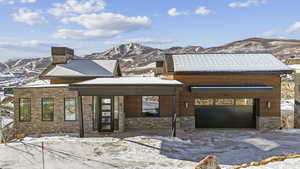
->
[[45, 59, 117, 77]]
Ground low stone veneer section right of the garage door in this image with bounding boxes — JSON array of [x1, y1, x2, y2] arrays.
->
[[256, 116, 281, 130]]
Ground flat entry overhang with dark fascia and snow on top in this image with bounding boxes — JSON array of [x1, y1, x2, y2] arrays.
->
[[69, 77, 182, 96]]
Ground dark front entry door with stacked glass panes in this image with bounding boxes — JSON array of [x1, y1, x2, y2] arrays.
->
[[99, 97, 114, 132]]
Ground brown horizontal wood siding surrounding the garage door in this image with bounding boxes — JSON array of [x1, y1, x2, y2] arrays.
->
[[169, 74, 281, 116]]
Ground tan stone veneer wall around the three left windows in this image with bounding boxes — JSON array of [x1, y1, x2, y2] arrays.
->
[[14, 87, 93, 134]]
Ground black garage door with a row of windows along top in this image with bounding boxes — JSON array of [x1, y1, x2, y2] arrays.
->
[[195, 98, 257, 128]]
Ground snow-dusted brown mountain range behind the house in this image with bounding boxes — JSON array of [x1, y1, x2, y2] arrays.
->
[[0, 38, 300, 88]]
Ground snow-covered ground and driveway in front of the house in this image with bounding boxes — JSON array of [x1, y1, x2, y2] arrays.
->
[[0, 129, 300, 169]]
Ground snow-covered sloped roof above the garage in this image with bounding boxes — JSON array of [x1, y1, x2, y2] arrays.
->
[[172, 54, 292, 72]]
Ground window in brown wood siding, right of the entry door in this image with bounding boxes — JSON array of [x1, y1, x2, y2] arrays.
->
[[142, 96, 160, 117]]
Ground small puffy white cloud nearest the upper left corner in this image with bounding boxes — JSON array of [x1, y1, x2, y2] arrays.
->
[[13, 8, 47, 25]]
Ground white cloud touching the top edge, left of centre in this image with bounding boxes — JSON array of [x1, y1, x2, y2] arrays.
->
[[48, 0, 105, 17]]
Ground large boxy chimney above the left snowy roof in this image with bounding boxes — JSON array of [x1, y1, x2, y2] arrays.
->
[[51, 47, 74, 64]]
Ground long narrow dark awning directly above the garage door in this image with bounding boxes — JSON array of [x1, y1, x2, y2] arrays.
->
[[190, 86, 273, 93]]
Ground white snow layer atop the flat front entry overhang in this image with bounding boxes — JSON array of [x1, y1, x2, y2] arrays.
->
[[72, 77, 182, 85]]
